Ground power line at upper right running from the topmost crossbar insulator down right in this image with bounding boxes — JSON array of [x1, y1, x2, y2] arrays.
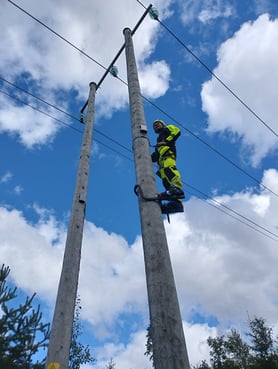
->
[[136, 0, 278, 137]]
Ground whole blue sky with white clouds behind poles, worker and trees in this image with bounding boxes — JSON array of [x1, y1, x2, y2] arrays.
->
[[0, 0, 278, 369]]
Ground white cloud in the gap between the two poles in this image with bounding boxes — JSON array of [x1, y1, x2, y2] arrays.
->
[[80, 223, 146, 334]]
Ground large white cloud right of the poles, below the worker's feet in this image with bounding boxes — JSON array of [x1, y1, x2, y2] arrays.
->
[[167, 170, 278, 321]]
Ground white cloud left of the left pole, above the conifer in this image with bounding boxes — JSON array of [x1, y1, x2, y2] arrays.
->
[[0, 207, 63, 302]]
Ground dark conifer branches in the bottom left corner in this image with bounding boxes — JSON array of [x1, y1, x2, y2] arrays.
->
[[0, 265, 49, 369]]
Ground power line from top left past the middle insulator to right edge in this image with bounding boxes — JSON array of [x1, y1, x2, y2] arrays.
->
[[8, 0, 278, 197]]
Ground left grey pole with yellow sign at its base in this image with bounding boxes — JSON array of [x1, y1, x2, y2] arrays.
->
[[46, 83, 96, 369]]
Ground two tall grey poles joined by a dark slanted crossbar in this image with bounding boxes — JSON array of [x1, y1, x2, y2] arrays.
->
[[45, 5, 190, 369]]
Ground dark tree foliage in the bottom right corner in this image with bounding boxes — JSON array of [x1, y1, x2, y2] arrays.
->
[[194, 317, 278, 369]]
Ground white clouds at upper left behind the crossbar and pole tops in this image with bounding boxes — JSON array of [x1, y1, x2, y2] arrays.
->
[[0, 0, 171, 147]]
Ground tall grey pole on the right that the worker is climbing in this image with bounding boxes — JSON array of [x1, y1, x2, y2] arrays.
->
[[124, 28, 190, 369]]
